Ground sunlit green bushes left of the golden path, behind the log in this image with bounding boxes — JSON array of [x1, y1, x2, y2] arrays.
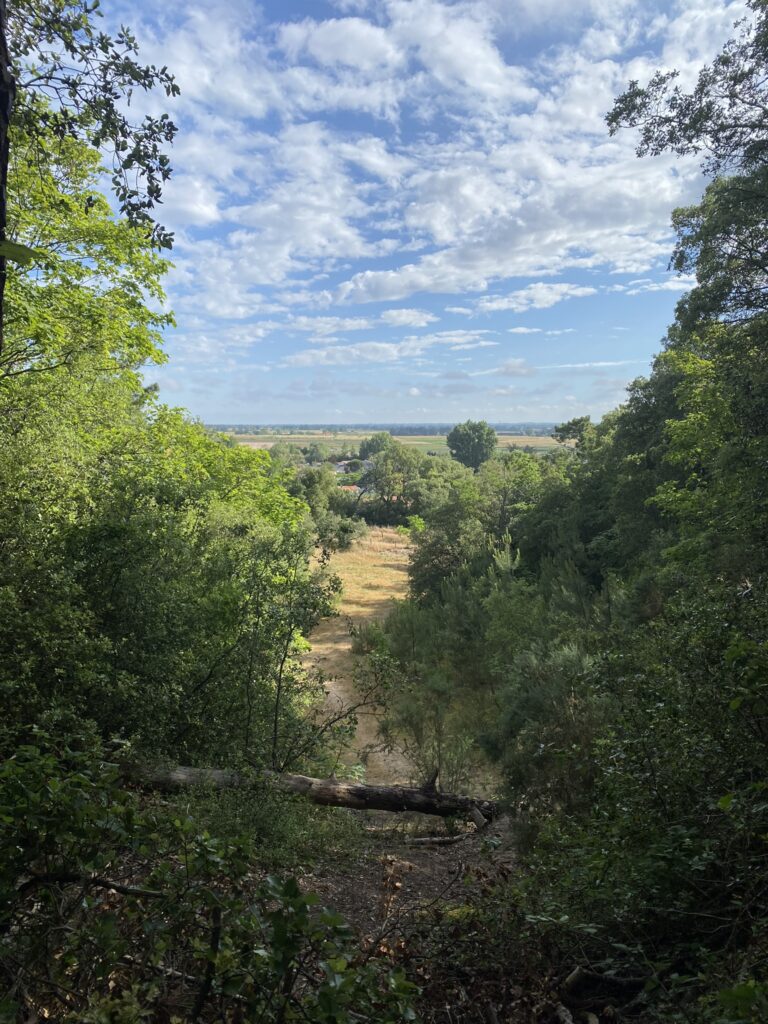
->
[[0, 365, 335, 765]]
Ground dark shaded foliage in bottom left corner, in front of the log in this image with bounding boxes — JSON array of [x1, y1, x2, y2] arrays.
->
[[0, 734, 414, 1024]]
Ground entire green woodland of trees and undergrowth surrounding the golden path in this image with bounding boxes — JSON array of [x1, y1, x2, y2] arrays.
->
[[0, 0, 768, 1024]]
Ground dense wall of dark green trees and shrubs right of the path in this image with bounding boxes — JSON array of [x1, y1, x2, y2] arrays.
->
[[367, 9, 768, 1024]]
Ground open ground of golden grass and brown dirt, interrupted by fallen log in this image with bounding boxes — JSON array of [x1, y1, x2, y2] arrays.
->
[[297, 527, 514, 1024]]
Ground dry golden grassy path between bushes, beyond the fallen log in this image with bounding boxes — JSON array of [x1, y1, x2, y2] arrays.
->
[[307, 526, 410, 784]]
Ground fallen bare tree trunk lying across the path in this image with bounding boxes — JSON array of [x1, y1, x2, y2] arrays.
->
[[125, 766, 499, 821]]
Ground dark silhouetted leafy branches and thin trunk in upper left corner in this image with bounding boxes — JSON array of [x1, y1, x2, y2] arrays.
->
[[0, 0, 178, 357]]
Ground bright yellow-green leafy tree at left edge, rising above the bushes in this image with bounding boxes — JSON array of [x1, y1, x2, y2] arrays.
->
[[0, 123, 173, 382]]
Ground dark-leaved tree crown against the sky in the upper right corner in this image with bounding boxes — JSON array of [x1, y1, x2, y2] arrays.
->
[[607, 0, 768, 329]]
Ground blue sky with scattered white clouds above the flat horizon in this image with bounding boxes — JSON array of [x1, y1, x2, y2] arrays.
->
[[117, 0, 744, 424]]
